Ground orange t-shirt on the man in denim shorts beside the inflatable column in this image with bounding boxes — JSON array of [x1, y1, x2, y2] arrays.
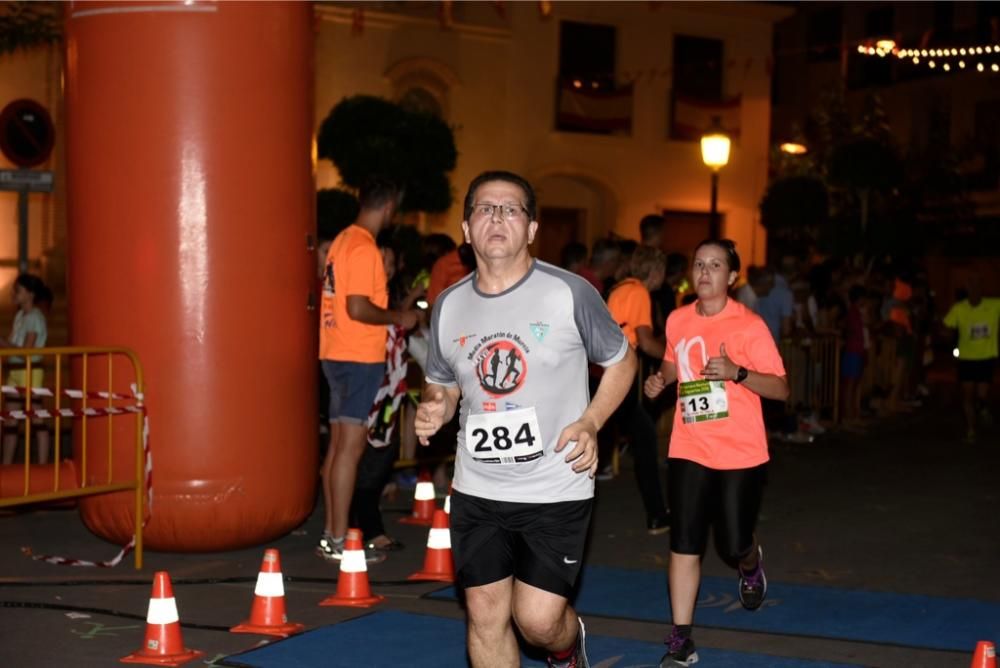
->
[[319, 225, 389, 364]]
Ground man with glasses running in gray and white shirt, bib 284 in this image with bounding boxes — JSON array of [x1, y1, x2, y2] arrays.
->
[[416, 171, 636, 668]]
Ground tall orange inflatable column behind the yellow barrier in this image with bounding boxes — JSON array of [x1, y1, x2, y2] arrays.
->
[[66, 0, 317, 551]]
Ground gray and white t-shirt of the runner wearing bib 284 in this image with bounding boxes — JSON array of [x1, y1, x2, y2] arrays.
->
[[427, 260, 628, 503]]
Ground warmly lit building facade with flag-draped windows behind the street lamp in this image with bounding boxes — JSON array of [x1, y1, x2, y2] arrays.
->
[[316, 2, 791, 261]]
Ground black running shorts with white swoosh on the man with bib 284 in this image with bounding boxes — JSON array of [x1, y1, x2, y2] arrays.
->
[[450, 491, 593, 598]]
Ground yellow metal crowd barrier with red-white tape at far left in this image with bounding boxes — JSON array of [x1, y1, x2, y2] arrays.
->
[[0, 346, 145, 569]]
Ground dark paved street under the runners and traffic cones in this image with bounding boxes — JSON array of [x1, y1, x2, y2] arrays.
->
[[0, 385, 1000, 668]]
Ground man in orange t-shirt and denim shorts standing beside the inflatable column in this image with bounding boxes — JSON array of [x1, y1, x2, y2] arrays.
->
[[316, 178, 418, 560]]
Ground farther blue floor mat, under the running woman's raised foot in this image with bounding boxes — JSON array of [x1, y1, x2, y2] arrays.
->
[[430, 566, 1000, 651]]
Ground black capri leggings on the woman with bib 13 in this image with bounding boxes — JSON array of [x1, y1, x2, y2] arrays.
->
[[667, 458, 767, 562]]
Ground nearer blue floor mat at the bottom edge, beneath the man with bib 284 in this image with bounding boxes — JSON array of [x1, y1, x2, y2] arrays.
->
[[217, 610, 850, 668]]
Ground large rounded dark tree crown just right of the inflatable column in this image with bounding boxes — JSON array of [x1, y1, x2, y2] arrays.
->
[[317, 95, 458, 212]]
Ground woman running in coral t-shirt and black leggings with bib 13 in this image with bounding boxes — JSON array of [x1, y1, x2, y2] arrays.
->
[[644, 239, 788, 668]]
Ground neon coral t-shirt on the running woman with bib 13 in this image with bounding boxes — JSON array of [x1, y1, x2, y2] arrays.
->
[[663, 299, 785, 469]]
